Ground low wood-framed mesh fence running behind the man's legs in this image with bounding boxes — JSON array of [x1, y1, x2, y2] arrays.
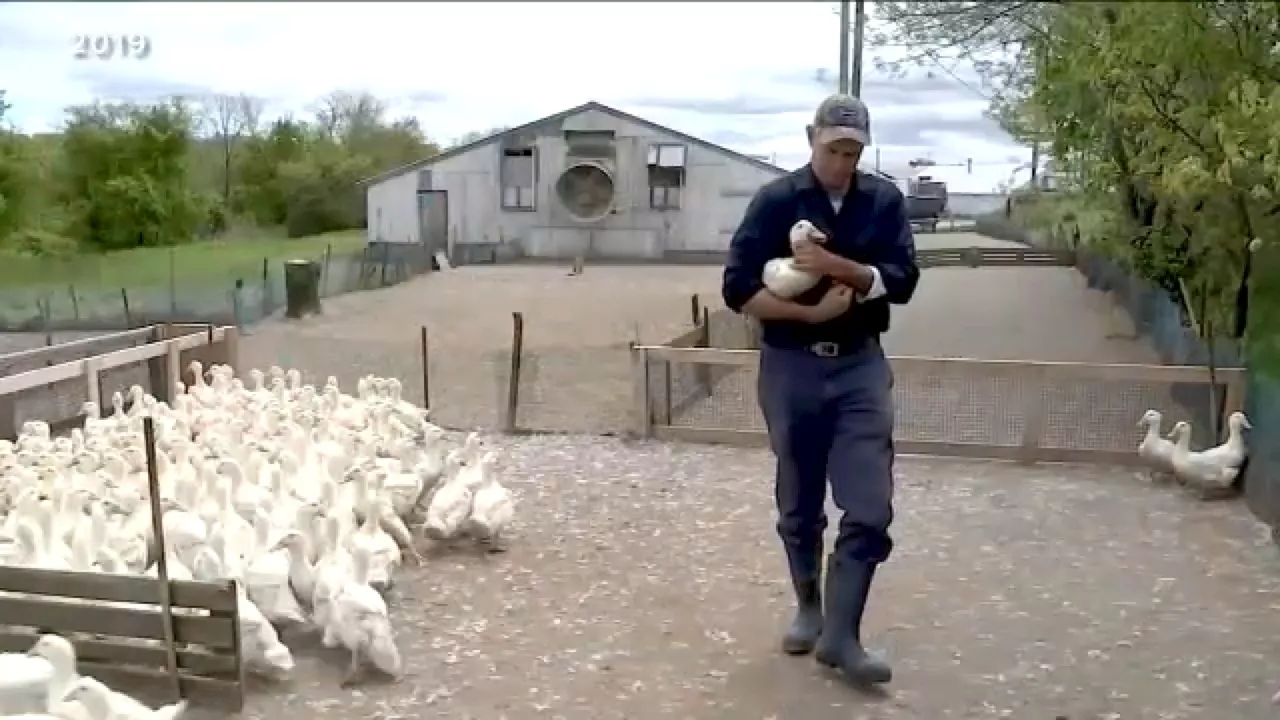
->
[[632, 346, 1245, 465]]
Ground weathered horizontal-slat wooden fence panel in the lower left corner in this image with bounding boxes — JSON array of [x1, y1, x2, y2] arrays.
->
[[0, 566, 244, 711]]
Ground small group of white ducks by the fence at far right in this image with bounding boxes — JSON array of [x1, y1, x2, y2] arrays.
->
[[1138, 410, 1252, 491]]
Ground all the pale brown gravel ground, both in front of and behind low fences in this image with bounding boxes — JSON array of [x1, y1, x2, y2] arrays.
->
[[10, 233, 1280, 720]]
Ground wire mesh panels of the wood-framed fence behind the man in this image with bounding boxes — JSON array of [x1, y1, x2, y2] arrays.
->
[[646, 352, 1228, 455]]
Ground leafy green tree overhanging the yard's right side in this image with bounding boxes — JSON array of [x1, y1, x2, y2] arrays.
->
[[877, 1, 1280, 368]]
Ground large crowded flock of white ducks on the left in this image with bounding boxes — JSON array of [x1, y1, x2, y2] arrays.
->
[[0, 363, 515, 720]]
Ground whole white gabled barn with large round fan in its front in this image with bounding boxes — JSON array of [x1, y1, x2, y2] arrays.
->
[[364, 102, 786, 264]]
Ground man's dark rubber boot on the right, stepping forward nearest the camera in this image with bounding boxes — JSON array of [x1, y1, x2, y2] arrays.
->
[[814, 556, 893, 687]]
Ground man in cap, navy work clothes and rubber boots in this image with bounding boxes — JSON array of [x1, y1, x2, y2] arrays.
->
[[723, 95, 919, 685]]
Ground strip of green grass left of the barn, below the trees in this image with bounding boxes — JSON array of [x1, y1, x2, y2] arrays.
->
[[0, 229, 365, 292]]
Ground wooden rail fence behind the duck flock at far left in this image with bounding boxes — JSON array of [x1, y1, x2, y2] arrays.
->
[[0, 323, 239, 438]]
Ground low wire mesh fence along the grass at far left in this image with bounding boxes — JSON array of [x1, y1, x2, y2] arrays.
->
[[0, 243, 431, 332]]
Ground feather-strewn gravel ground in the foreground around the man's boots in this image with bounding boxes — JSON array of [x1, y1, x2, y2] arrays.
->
[[183, 437, 1280, 720]]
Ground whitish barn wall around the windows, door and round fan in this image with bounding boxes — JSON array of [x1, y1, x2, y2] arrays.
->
[[369, 105, 781, 263]]
